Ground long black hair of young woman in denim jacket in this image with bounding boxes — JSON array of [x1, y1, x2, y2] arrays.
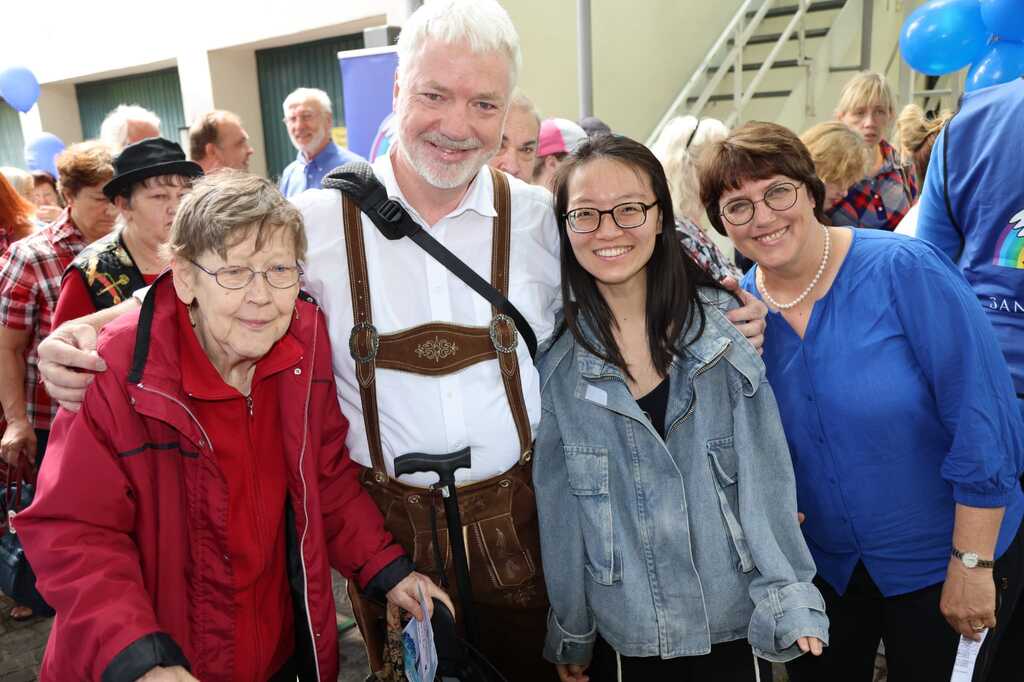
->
[[554, 135, 722, 379]]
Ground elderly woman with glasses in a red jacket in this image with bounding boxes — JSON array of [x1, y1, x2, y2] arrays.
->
[[16, 172, 447, 682]]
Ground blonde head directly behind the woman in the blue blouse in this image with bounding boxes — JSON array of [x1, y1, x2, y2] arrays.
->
[[800, 121, 870, 211]]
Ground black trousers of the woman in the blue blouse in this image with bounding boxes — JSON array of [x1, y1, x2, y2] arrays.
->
[[786, 520, 1024, 682]]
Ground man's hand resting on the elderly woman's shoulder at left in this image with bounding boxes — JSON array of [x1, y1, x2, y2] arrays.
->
[[39, 322, 106, 412]]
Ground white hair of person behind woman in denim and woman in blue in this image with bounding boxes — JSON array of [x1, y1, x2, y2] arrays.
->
[[650, 116, 729, 224]]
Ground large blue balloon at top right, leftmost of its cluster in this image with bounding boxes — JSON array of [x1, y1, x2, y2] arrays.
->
[[899, 0, 989, 76]]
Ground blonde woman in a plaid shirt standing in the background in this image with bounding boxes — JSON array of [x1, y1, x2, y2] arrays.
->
[[826, 71, 918, 231]]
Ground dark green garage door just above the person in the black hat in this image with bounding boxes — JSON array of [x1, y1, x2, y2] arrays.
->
[[75, 69, 187, 142]]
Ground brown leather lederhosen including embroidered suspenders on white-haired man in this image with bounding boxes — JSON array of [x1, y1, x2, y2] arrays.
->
[[343, 171, 548, 671]]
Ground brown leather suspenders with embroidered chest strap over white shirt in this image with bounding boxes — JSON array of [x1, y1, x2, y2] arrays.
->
[[342, 170, 532, 483]]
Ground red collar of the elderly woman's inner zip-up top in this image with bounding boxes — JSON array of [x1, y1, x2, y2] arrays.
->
[[174, 296, 302, 400]]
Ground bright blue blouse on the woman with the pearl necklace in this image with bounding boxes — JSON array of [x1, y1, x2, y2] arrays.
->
[[743, 229, 1024, 596]]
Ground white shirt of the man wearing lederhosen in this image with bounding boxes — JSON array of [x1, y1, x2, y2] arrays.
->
[[294, 156, 560, 486]]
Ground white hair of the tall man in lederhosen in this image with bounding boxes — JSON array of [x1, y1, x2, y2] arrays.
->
[[398, 0, 522, 89]]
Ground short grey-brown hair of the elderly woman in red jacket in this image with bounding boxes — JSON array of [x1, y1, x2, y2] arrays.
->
[[168, 169, 306, 260]]
